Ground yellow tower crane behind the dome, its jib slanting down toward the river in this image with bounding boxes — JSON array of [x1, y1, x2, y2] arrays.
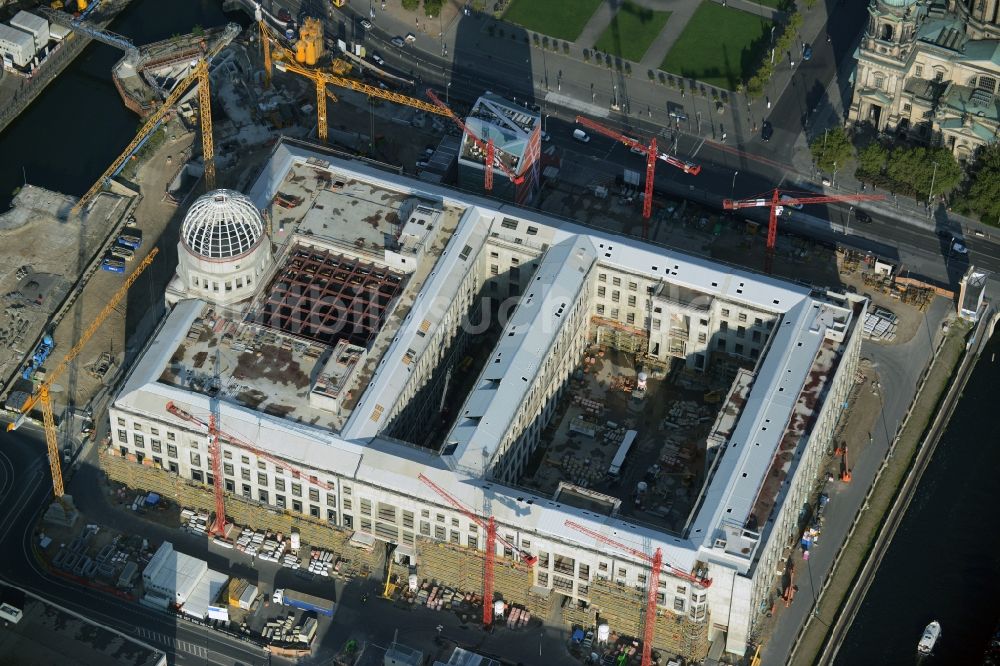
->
[[71, 23, 240, 214]]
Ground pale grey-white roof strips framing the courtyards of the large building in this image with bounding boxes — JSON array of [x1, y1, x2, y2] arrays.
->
[[116, 142, 853, 570]]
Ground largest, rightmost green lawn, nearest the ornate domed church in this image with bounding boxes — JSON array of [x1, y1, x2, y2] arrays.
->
[[660, 2, 772, 90]]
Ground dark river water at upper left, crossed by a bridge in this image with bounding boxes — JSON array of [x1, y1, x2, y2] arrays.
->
[[0, 0, 242, 211]]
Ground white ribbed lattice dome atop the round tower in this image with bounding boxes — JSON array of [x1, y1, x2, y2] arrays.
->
[[181, 190, 264, 259]]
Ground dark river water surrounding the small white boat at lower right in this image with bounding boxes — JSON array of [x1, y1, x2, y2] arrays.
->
[[836, 334, 1000, 666]]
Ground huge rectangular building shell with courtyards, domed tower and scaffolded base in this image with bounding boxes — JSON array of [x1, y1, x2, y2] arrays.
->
[[103, 136, 866, 658]]
